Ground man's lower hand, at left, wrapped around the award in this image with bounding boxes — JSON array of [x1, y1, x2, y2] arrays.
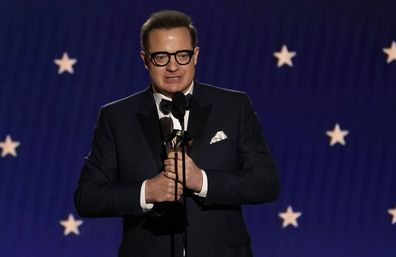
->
[[145, 172, 183, 203]]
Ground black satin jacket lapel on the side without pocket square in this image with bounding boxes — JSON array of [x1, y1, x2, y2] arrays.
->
[[136, 89, 163, 170]]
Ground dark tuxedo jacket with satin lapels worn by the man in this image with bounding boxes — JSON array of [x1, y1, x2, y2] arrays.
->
[[75, 82, 279, 257]]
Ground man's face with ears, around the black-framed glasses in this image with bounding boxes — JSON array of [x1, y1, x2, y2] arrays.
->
[[140, 27, 199, 97]]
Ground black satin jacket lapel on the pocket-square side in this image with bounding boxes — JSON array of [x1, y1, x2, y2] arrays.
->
[[188, 81, 211, 159]]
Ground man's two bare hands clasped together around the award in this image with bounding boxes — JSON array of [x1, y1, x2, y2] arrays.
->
[[145, 152, 202, 203]]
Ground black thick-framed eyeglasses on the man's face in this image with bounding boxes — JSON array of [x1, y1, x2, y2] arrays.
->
[[146, 50, 194, 67]]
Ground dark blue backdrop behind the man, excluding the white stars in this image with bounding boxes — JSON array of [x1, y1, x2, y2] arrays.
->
[[0, 0, 396, 257]]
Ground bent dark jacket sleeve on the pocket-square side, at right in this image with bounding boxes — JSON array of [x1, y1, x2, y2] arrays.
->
[[203, 94, 279, 205]]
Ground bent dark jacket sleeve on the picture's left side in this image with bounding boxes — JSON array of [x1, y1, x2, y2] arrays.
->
[[74, 108, 142, 217]]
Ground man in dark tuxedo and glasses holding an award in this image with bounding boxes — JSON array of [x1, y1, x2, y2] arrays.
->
[[74, 11, 279, 257]]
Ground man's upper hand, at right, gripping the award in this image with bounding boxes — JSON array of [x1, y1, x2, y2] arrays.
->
[[164, 152, 202, 193]]
